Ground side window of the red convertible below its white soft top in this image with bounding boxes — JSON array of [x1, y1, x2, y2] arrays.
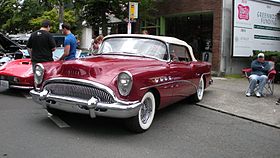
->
[[169, 44, 191, 62]]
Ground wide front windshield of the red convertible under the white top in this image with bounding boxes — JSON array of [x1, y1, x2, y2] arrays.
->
[[98, 37, 167, 60]]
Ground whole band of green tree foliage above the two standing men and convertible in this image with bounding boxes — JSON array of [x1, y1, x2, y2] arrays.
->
[[0, 0, 157, 34]]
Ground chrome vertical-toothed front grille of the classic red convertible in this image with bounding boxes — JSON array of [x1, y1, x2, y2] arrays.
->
[[45, 83, 114, 103]]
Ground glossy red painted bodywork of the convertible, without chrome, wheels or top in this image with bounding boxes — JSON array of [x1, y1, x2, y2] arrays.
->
[[38, 55, 211, 108]]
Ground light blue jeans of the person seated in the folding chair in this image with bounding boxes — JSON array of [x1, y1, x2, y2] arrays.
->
[[249, 75, 267, 95]]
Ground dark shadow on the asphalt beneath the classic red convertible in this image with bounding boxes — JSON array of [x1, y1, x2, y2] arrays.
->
[[35, 99, 196, 136]]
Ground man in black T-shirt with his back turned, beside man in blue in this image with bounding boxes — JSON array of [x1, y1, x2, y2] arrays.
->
[[27, 20, 56, 73]]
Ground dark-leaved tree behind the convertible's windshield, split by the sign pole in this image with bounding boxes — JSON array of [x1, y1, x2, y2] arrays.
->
[[76, 0, 157, 34]]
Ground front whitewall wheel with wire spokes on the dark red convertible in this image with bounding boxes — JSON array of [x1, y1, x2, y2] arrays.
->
[[126, 92, 156, 133]]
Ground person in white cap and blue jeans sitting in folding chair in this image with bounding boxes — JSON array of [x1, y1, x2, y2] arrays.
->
[[246, 53, 270, 98]]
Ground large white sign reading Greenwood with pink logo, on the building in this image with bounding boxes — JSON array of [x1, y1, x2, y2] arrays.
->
[[233, 0, 280, 57]]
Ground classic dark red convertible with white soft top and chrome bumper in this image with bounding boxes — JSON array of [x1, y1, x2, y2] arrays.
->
[[30, 35, 212, 132]]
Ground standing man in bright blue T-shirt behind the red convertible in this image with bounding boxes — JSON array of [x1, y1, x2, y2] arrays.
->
[[60, 23, 77, 60]]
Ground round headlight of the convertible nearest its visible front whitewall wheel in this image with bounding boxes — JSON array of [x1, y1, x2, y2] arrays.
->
[[118, 72, 132, 96]]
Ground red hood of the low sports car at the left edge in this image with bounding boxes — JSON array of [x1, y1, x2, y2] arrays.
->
[[0, 58, 33, 77]]
